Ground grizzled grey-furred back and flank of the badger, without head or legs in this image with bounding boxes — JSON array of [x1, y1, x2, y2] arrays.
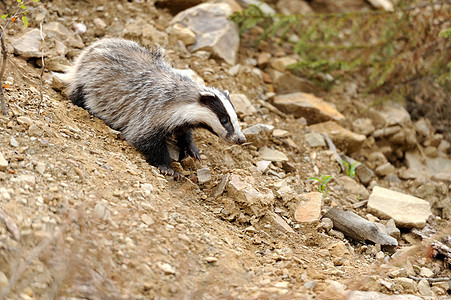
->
[[67, 39, 200, 142]]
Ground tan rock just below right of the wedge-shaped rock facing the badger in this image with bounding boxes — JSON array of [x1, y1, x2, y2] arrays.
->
[[310, 121, 366, 153]]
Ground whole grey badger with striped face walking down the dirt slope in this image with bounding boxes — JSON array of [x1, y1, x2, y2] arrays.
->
[[57, 38, 246, 177]]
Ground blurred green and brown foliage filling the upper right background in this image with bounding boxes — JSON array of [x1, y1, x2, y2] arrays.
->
[[231, 0, 451, 92]]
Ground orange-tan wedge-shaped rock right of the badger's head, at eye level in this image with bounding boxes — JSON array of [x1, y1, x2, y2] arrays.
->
[[273, 93, 345, 124]]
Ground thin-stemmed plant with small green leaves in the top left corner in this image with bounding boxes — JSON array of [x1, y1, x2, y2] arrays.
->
[[0, 0, 39, 115]]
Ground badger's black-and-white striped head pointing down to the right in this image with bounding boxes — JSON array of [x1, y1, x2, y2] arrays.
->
[[199, 88, 246, 144]]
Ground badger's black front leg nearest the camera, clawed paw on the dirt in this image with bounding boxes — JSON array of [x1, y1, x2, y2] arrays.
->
[[135, 134, 181, 178]]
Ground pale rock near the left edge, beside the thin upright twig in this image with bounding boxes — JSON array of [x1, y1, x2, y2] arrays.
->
[[11, 28, 45, 58]]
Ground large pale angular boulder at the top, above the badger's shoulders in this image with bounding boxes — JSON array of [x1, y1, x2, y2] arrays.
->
[[171, 3, 239, 65]]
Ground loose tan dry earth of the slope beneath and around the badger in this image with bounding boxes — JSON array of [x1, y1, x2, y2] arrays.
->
[[0, 1, 451, 299]]
